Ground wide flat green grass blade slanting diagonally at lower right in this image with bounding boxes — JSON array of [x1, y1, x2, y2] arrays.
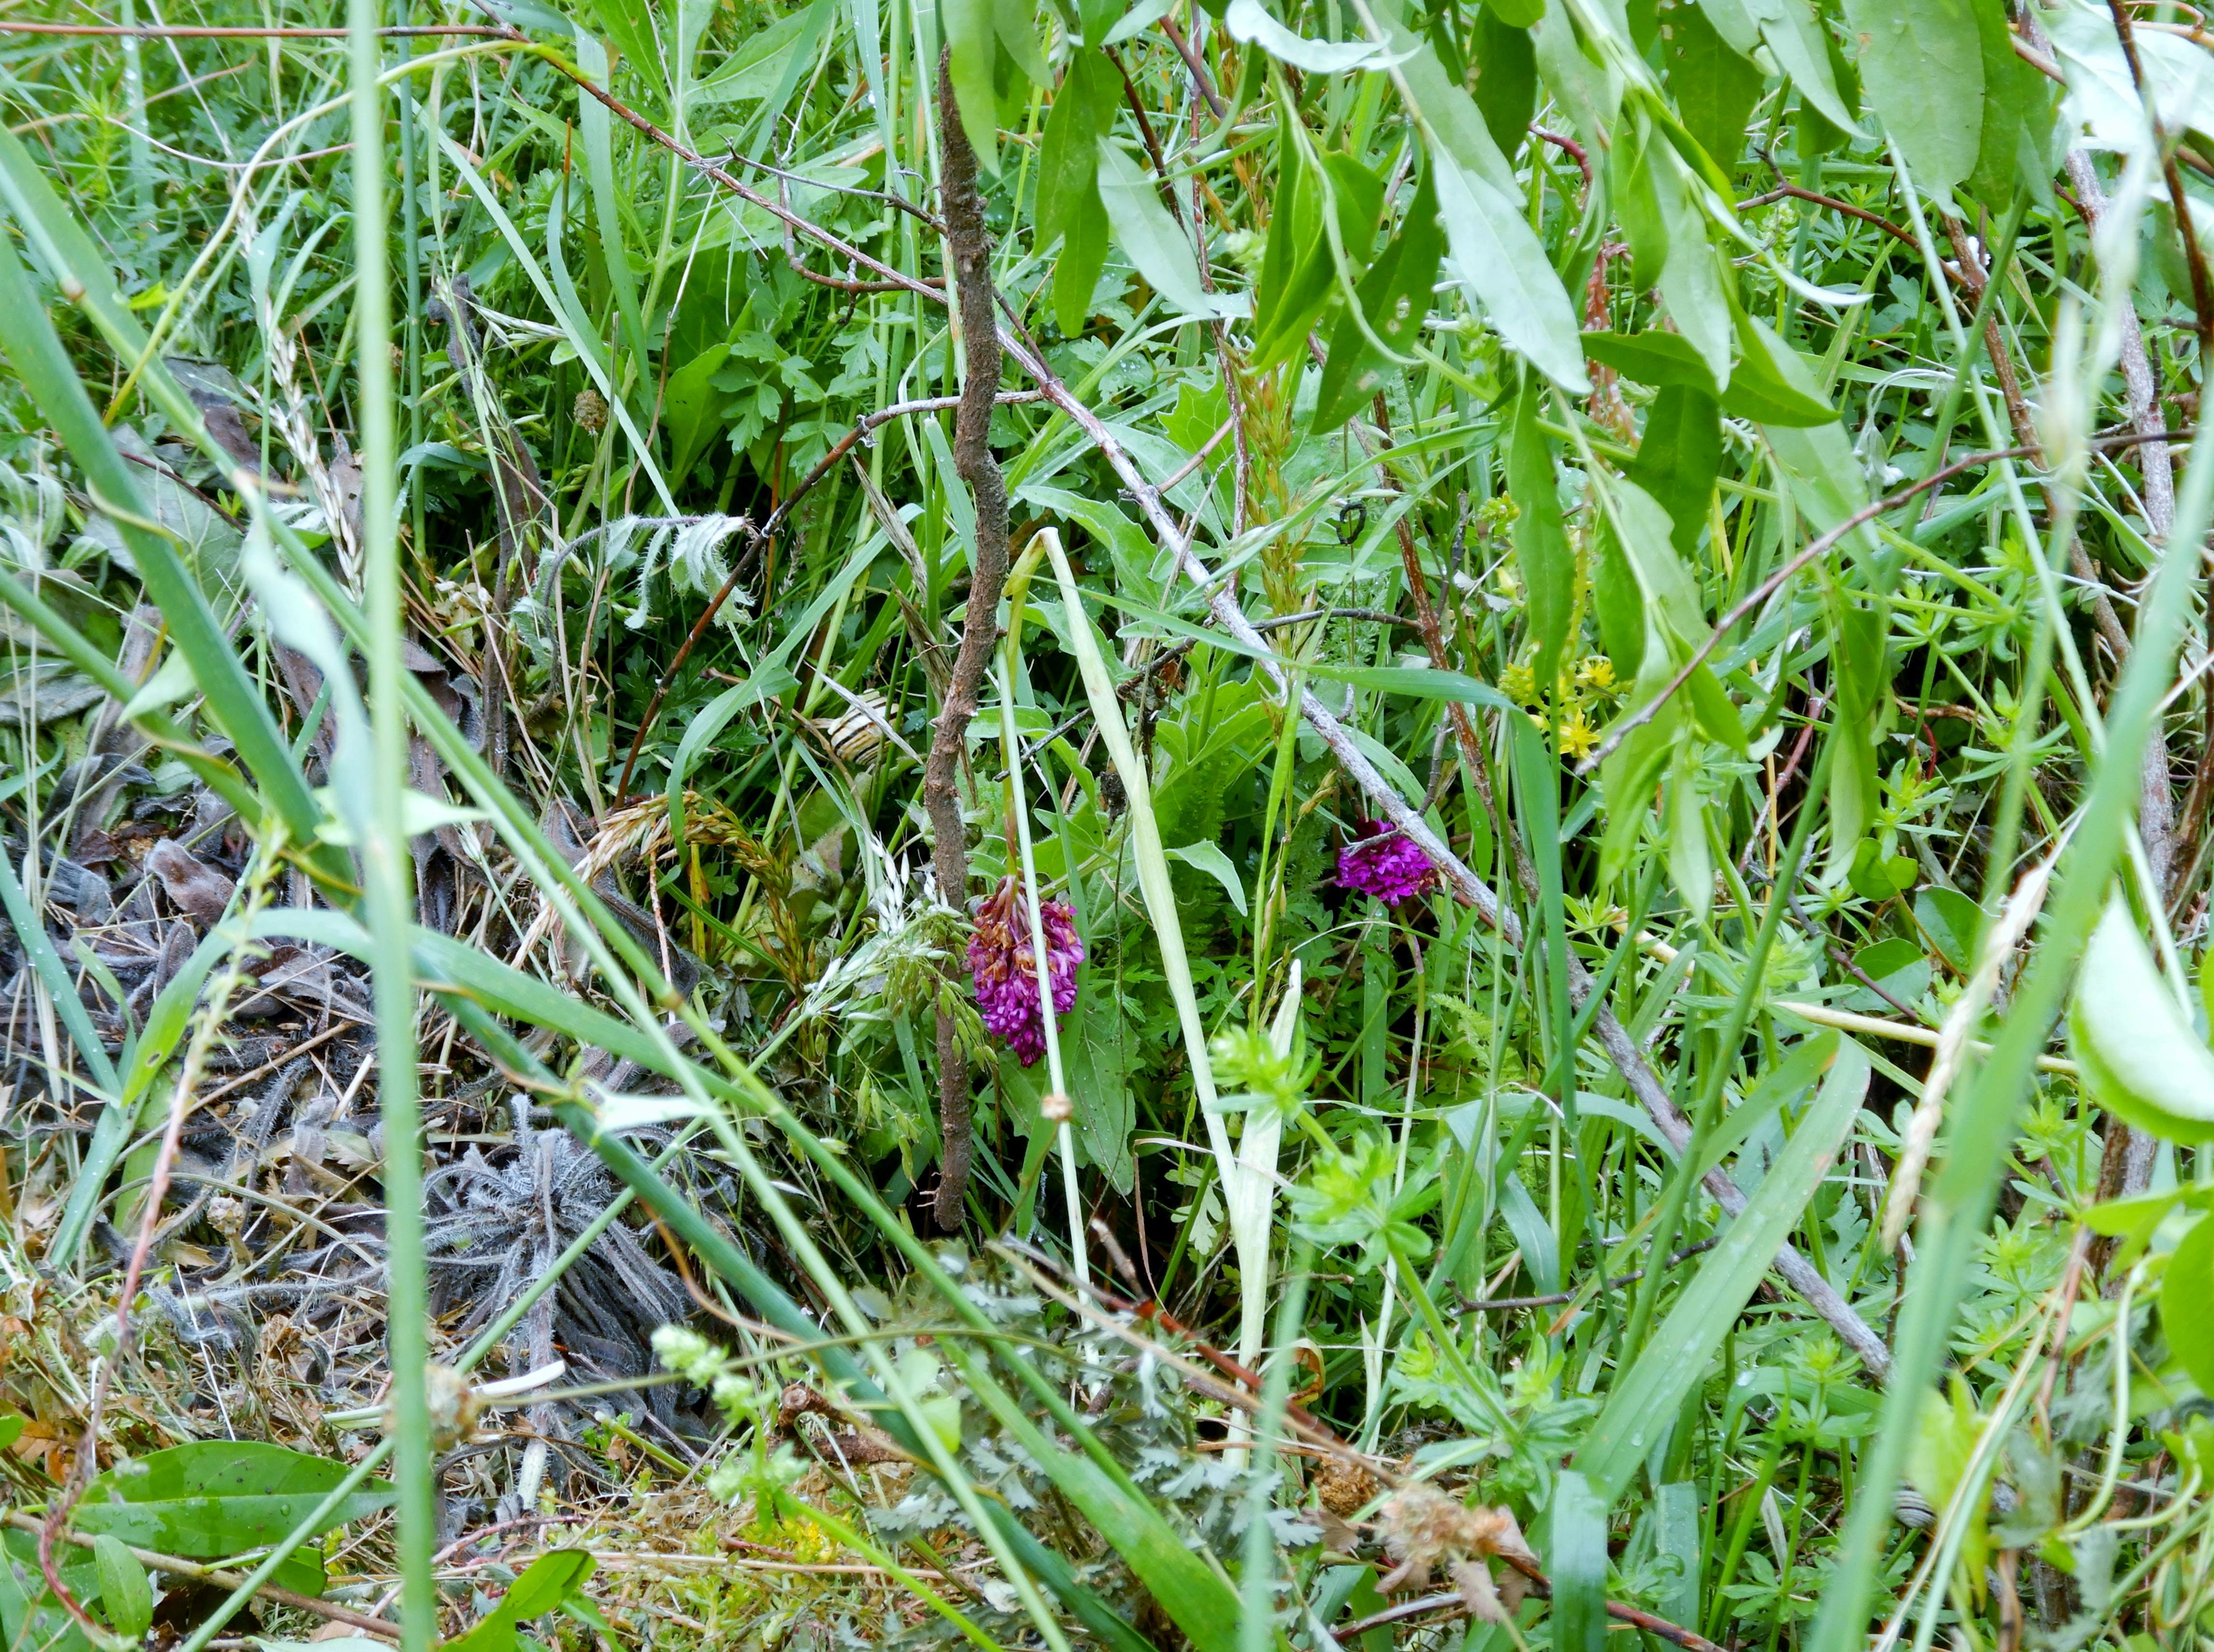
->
[[1576, 1043, 1869, 1506]]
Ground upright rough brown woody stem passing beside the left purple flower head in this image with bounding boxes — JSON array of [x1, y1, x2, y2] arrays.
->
[[923, 51, 1007, 1229]]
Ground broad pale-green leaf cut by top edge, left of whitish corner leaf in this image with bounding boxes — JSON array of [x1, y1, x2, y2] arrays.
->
[[1844, 0, 1984, 197]]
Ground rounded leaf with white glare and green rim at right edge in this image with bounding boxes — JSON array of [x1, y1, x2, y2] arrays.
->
[[2068, 899, 2214, 1143]]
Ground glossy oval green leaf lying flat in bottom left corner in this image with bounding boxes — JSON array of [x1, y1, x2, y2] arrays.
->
[[75, 1439, 392, 1559]]
